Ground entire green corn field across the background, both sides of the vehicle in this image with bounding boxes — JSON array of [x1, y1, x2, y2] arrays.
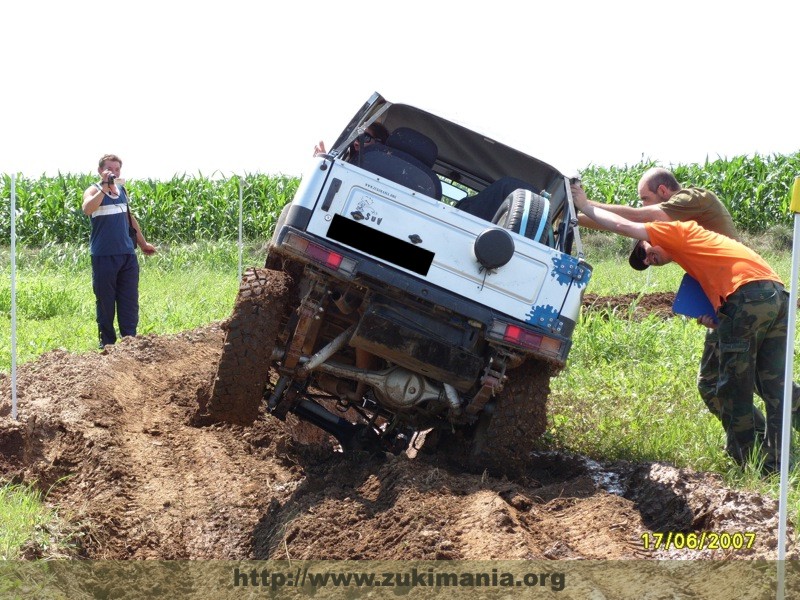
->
[[0, 152, 800, 247]]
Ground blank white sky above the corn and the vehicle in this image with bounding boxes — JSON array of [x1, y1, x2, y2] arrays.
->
[[0, 0, 800, 179]]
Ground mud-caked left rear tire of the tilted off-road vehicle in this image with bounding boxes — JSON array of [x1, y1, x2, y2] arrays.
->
[[206, 269, 293, 425]]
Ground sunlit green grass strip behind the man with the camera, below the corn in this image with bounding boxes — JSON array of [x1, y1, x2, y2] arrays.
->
[[0, 242, 263, 372]]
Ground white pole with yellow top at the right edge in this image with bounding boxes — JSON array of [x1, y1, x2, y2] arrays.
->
[[777, 177, 800, 600]]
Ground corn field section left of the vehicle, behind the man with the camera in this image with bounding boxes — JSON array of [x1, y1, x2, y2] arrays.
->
[[0, 174, 299, 247]]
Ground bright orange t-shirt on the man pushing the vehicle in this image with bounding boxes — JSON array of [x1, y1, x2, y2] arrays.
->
[[644, 221, 783, 308]]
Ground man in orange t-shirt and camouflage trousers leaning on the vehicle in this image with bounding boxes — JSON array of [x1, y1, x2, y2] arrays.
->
[[573, 186, 789, 472]]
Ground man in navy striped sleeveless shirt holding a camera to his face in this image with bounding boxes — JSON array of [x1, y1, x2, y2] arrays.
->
[[83, 154, 156, 348]]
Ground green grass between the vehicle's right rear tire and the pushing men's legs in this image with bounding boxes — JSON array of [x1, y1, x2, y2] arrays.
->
[[550, 313, 722, 468]]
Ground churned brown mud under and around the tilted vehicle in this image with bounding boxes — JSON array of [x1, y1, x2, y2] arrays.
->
[[0, 294, 797, 560]]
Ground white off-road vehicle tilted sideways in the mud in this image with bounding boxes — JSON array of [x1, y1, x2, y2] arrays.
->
[[207, 93, 591, 472]]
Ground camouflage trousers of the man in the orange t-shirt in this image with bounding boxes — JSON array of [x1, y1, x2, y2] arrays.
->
[[697, 281, 800, 470]]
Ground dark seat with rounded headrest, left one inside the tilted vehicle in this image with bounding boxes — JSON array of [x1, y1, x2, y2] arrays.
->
[[360, 127, 442, 200]]
